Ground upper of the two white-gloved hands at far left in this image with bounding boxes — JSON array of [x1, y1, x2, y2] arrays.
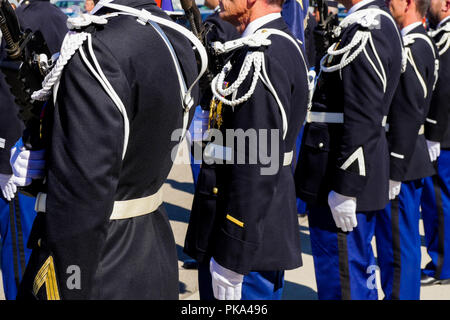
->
[[10, 139, 45, 187]]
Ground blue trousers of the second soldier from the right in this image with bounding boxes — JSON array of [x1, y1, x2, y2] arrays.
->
[[375, 179, 423, 300]]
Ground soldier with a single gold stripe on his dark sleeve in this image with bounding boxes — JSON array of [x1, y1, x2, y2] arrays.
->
[[184, 0, 308, 300]]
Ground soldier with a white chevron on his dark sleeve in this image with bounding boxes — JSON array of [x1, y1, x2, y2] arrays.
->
[[295, 0, 402, 299]]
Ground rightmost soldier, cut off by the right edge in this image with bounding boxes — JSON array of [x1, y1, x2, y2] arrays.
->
[[421, 0, 450, 285]]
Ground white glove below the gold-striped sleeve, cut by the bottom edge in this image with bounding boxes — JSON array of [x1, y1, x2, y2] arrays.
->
[[209, 258, 244, 300]]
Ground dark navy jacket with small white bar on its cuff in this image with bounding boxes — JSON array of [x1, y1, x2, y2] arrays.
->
[[387, 25, 439, 181]]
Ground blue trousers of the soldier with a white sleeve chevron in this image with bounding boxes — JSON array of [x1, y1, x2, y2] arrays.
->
[[308, 206, 378, 300]]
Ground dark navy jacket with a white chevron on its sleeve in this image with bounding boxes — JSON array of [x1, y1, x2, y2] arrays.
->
[[295, 0, 402, 211]]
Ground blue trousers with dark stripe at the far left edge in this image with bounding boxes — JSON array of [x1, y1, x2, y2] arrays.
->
[[0, 193, 36, 300]]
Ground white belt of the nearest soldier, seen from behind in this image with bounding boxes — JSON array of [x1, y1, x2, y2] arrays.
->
[[34, 188, 163, 220]]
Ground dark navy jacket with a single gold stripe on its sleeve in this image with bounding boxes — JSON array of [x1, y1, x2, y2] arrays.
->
[[184, 18, 308, 274]]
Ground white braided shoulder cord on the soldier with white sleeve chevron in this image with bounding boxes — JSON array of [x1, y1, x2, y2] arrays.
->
[[320, 8, 406, 92]]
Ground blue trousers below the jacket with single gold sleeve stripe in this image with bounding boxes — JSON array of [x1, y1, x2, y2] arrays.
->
[[198, 263, 284, 300]]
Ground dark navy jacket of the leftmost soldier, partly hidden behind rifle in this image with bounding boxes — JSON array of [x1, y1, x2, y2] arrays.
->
[[0, 0, 67, 174]]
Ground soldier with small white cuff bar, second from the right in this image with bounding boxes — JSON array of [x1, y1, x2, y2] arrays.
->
[[375, 0, 439, 300]]
